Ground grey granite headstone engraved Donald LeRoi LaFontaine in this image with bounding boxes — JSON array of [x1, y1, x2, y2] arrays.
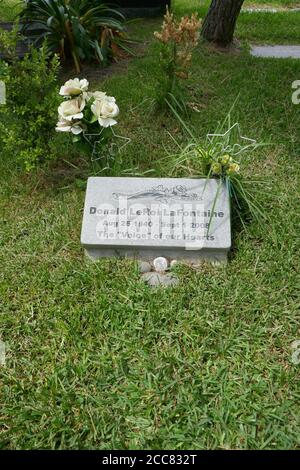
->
[[81, 177, 231, 263]]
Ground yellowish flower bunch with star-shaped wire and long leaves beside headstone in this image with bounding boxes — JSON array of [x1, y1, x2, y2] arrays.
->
[[166, 108, 266, 229]]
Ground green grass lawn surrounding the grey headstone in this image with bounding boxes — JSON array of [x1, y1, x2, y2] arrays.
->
[[0, 0, 300, 449]]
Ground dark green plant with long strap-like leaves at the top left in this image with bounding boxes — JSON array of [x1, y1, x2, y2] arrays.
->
[[20, 0, 132, 72]]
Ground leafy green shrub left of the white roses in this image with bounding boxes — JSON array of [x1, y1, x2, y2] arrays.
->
[[0, 29, 59, 171]]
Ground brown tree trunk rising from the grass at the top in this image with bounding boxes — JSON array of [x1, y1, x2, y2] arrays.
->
[[201, 0, 244, 46]]
